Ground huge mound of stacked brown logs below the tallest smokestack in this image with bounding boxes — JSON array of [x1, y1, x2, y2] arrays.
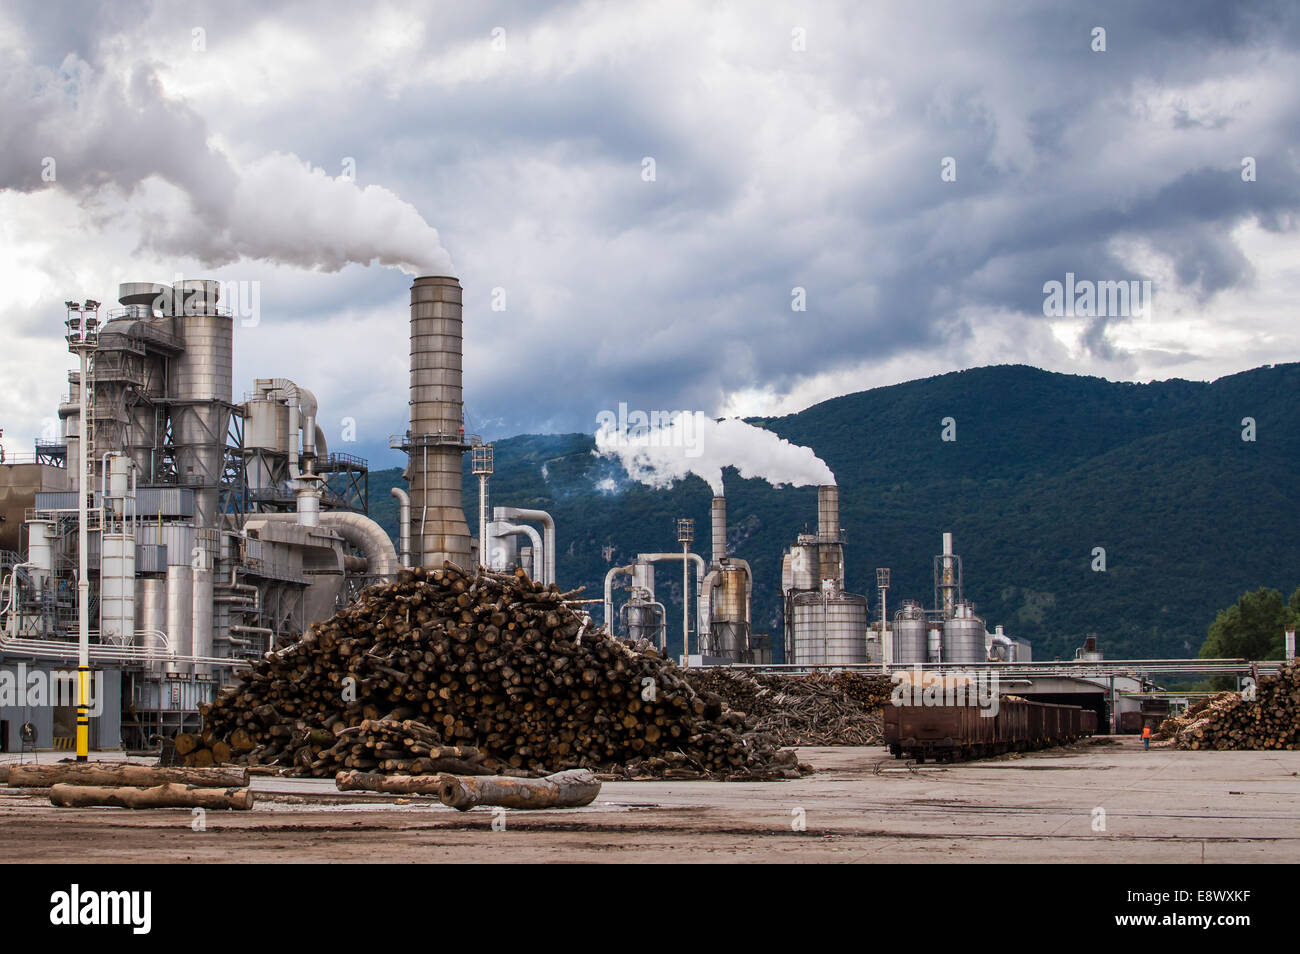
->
[[197, 563, 801, 777]]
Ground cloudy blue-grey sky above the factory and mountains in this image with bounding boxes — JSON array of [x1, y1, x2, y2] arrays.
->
[[0, 0, 1300, 465]]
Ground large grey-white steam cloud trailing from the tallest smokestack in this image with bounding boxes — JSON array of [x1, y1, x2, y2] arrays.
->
[[0, 56, 454, 274]]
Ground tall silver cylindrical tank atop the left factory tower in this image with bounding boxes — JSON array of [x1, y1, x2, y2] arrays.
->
[[172, 281, 234, 538]]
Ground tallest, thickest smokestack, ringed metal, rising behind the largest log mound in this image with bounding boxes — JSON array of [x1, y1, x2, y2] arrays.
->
[[404, 277, 473, 571]]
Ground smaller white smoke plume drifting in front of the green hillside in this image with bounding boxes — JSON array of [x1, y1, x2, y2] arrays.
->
[[595, 406, 835, 496]]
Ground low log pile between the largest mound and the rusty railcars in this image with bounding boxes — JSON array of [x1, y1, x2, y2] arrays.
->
[[688, 669, 893, 746]]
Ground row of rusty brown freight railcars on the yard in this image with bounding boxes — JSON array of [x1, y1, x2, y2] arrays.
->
[[884, 695, 1097, 762]]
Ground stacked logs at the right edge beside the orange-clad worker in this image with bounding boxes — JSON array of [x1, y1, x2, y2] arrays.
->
[[1156, 662, 1300, 750]]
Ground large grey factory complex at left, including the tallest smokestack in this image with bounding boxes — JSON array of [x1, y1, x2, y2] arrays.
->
[[0, 277, 491, 750]]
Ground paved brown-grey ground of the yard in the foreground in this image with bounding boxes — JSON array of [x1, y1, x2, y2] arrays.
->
[[0, 737, 1300, 863]]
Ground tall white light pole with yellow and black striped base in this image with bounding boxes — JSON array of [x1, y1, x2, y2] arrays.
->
[[64, 299, 99, 762]]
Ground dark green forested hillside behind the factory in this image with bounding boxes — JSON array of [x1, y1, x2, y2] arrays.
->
[[371, 364, 1300, 659]]
